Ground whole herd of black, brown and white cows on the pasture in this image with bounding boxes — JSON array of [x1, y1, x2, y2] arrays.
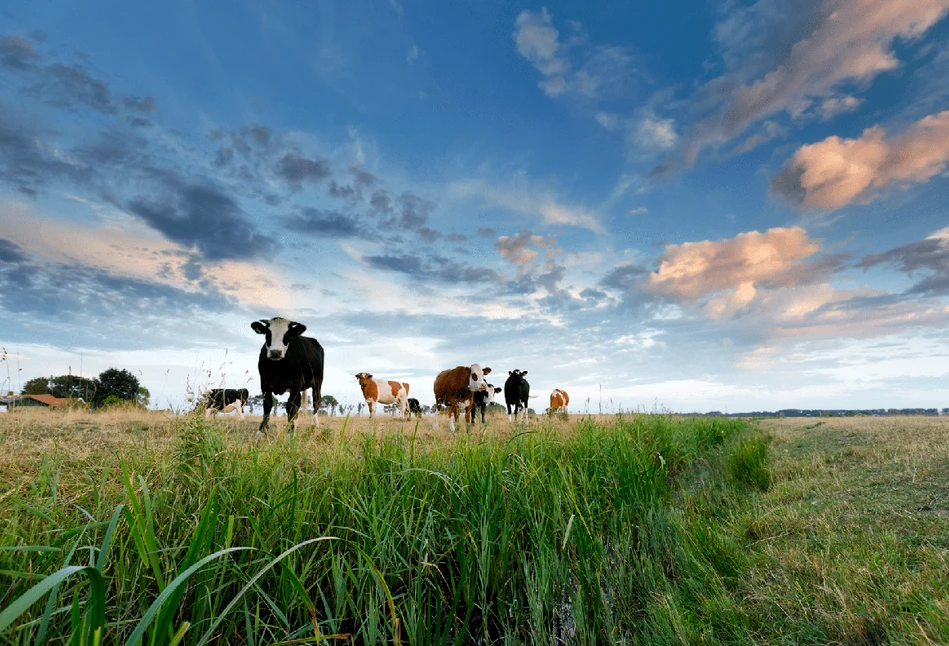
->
[[189, 317, 570, 433]]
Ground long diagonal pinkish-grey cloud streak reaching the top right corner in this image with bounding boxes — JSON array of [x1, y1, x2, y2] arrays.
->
[[683, 0, 949, 170]]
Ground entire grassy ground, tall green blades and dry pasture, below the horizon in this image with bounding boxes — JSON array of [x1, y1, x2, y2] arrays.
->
[[0, 411, 949, 644]]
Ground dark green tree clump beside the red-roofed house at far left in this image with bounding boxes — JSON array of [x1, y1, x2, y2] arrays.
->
[[21, 368, 151, 408]]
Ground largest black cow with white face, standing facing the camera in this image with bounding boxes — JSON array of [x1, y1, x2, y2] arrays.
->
[[250, 317, 323, 433]]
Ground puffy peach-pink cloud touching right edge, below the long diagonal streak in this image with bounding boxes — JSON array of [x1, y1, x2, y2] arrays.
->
[[771, 110, 949, 210]]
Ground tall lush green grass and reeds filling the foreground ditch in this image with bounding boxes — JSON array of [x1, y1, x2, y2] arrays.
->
[[0, 415, 764, 645]]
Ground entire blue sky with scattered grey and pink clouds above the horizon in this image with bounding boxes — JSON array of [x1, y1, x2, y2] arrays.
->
[[0, 0, 949, 412]]
